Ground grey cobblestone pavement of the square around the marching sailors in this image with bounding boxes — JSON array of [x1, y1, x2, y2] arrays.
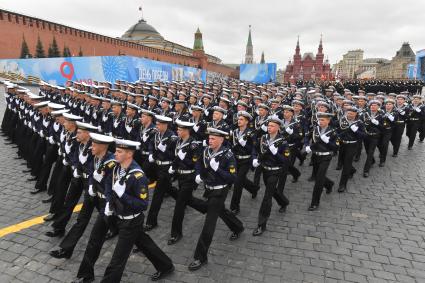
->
[[0, 86, 425, 283]]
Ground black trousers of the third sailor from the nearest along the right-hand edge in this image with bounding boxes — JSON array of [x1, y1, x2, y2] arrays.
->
[[258, 168, 289, 229]]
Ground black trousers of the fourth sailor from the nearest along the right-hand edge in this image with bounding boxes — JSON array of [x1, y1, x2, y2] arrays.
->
[[311, 153, 333, 205]]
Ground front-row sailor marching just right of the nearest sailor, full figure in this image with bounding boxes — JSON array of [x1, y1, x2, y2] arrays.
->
[[189, 128, 244, 271]]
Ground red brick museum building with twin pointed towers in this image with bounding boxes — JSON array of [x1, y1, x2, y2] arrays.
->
[[284, 38, 332, 82]]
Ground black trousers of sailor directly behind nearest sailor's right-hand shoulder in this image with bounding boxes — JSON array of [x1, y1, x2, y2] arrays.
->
[[146, 165, 177, 226]]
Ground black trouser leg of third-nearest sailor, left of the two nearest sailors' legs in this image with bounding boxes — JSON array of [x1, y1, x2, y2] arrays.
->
[[59, 191, 98, 253]]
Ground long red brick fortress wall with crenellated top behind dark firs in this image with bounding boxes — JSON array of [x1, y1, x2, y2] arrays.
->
[[0, 10, 234, 76]]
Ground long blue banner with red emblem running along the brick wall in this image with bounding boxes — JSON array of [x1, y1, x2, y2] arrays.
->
[[0, 56, 207, 85]]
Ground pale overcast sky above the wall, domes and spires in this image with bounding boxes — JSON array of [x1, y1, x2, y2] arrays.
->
[[0, 0, 425, 68]]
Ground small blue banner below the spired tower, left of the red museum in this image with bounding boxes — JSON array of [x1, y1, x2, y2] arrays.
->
[[239, 63, 277, 83]]
